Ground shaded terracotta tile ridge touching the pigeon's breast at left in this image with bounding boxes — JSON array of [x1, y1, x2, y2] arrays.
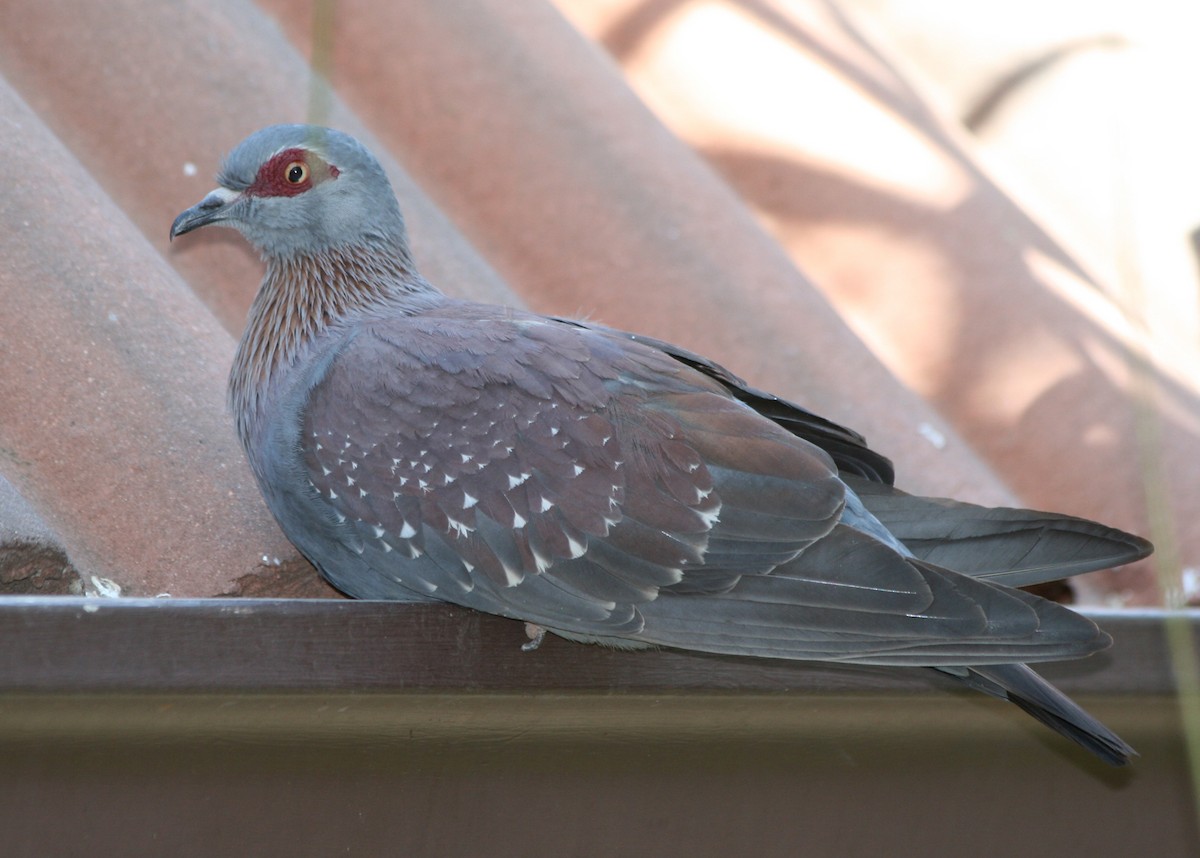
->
[[0, 82, 300, 595]]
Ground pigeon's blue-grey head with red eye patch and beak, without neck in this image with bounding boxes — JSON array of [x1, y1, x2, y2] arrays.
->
[[170, 125, 406, 259]]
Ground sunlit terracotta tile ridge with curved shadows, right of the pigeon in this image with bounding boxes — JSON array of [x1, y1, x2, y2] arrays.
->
[[557, 0, 1200, 601]]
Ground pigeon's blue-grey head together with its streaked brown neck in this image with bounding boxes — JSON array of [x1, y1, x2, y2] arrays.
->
[[170, 125, 440, 453]]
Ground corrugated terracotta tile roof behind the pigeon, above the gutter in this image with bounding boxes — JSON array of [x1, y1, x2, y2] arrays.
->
[[0, 0, 1200, 602]]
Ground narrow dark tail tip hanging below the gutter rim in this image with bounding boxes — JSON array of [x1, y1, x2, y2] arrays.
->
[[947, 665, 1138, 766]]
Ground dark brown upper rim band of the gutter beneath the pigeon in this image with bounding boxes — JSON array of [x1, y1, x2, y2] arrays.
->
[[0, 596, 1200, 695]]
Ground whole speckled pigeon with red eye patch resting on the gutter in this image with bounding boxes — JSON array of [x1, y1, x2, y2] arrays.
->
[[170, 125, 1151, 764]]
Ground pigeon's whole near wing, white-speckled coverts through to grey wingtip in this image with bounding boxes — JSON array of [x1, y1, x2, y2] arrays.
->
[[301, 304, 1105, 665]]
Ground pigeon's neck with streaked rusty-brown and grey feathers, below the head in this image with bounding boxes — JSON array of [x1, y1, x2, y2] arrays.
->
[[229, 240, 440, 448]]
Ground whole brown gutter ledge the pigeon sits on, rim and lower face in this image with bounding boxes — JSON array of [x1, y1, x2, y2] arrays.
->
[[0, 596, 1200, 858]]
